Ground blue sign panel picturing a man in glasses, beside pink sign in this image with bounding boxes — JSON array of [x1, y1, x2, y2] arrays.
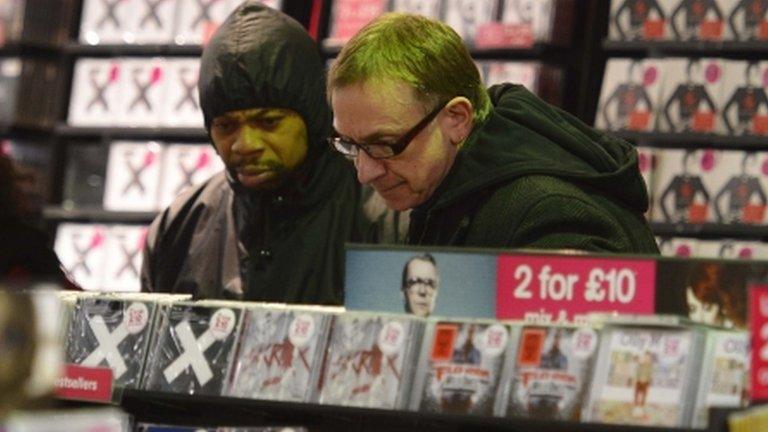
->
[[345, 246, 496, 318]]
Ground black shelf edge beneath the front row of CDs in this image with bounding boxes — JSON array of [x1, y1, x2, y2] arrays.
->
[[62, 390, 734, 432]]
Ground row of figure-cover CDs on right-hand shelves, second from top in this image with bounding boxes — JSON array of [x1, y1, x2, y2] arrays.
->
[[595, 58, 768, 136]]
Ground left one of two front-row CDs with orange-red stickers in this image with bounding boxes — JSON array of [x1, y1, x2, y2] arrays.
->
[[411, 319, 514, 416]]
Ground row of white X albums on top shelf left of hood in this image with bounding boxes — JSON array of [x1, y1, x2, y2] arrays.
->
[[79, 0, 282, 45]]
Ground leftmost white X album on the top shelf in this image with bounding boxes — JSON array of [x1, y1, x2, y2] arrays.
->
[[79, 0, 135, 45]]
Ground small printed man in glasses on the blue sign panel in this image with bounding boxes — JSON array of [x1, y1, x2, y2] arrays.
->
[[402, 253, 440, 318]]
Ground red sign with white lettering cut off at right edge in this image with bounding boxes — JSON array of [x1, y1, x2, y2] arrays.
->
[[749, 285, 768, 400]]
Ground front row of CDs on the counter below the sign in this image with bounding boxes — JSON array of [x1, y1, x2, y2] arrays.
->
[[63, 294, 748, 427]]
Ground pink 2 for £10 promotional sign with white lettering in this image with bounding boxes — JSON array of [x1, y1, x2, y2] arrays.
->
[[496, 255, 656, 321]]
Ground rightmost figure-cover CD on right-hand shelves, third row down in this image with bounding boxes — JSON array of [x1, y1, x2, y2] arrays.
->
[[709, 150, 768, 225]]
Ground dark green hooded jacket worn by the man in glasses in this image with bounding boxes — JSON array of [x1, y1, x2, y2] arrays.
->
[[408, 84, 658, 253]]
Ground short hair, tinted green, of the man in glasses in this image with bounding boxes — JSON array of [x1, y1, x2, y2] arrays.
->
[[327, 13, 491, 122]]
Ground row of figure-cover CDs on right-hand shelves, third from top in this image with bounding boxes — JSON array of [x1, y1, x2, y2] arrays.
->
[[638, 147, 768, 225]]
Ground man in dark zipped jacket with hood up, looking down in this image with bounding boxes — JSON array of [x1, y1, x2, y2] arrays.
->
[[142, 1, 363, 304]]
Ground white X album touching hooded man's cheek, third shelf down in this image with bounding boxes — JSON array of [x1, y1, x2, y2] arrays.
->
[[158, 143, 224, 208]]
